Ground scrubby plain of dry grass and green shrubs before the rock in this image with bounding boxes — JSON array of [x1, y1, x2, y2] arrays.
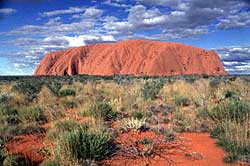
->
[[0, 76, 250, 165]]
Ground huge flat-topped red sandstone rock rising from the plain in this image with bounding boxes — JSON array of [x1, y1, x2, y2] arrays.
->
[[34, 40, 227, 76]]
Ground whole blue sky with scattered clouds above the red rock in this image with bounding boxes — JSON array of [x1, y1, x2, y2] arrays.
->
[[0, 0, 250, 75]]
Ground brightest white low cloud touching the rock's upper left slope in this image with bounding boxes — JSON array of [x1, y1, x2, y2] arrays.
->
[[0, 34, 116, 74]]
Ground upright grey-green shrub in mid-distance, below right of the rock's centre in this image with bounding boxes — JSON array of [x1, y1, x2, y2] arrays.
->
[[142, 80, 164, 100]]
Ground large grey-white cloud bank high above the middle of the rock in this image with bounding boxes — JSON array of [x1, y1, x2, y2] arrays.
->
[[104, 5, 210, 40]]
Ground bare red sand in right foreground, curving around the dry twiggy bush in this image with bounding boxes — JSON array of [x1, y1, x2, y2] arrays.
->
[[102, 132, 236, 166]]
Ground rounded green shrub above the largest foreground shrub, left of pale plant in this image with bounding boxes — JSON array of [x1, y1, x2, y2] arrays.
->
[[89, 102, 117, 121]]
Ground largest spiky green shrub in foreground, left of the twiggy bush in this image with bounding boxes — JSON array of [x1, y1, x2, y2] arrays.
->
[[57, 124, 113, 161]]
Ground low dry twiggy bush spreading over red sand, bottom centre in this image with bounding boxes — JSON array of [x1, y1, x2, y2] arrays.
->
[[118, 132, 182, 162]]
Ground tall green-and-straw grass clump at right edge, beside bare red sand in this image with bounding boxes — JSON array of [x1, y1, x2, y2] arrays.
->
[[209, 100, 250, 162]]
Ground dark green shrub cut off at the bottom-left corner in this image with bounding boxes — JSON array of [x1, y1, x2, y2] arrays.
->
[[3, 155, 30, 166]]
